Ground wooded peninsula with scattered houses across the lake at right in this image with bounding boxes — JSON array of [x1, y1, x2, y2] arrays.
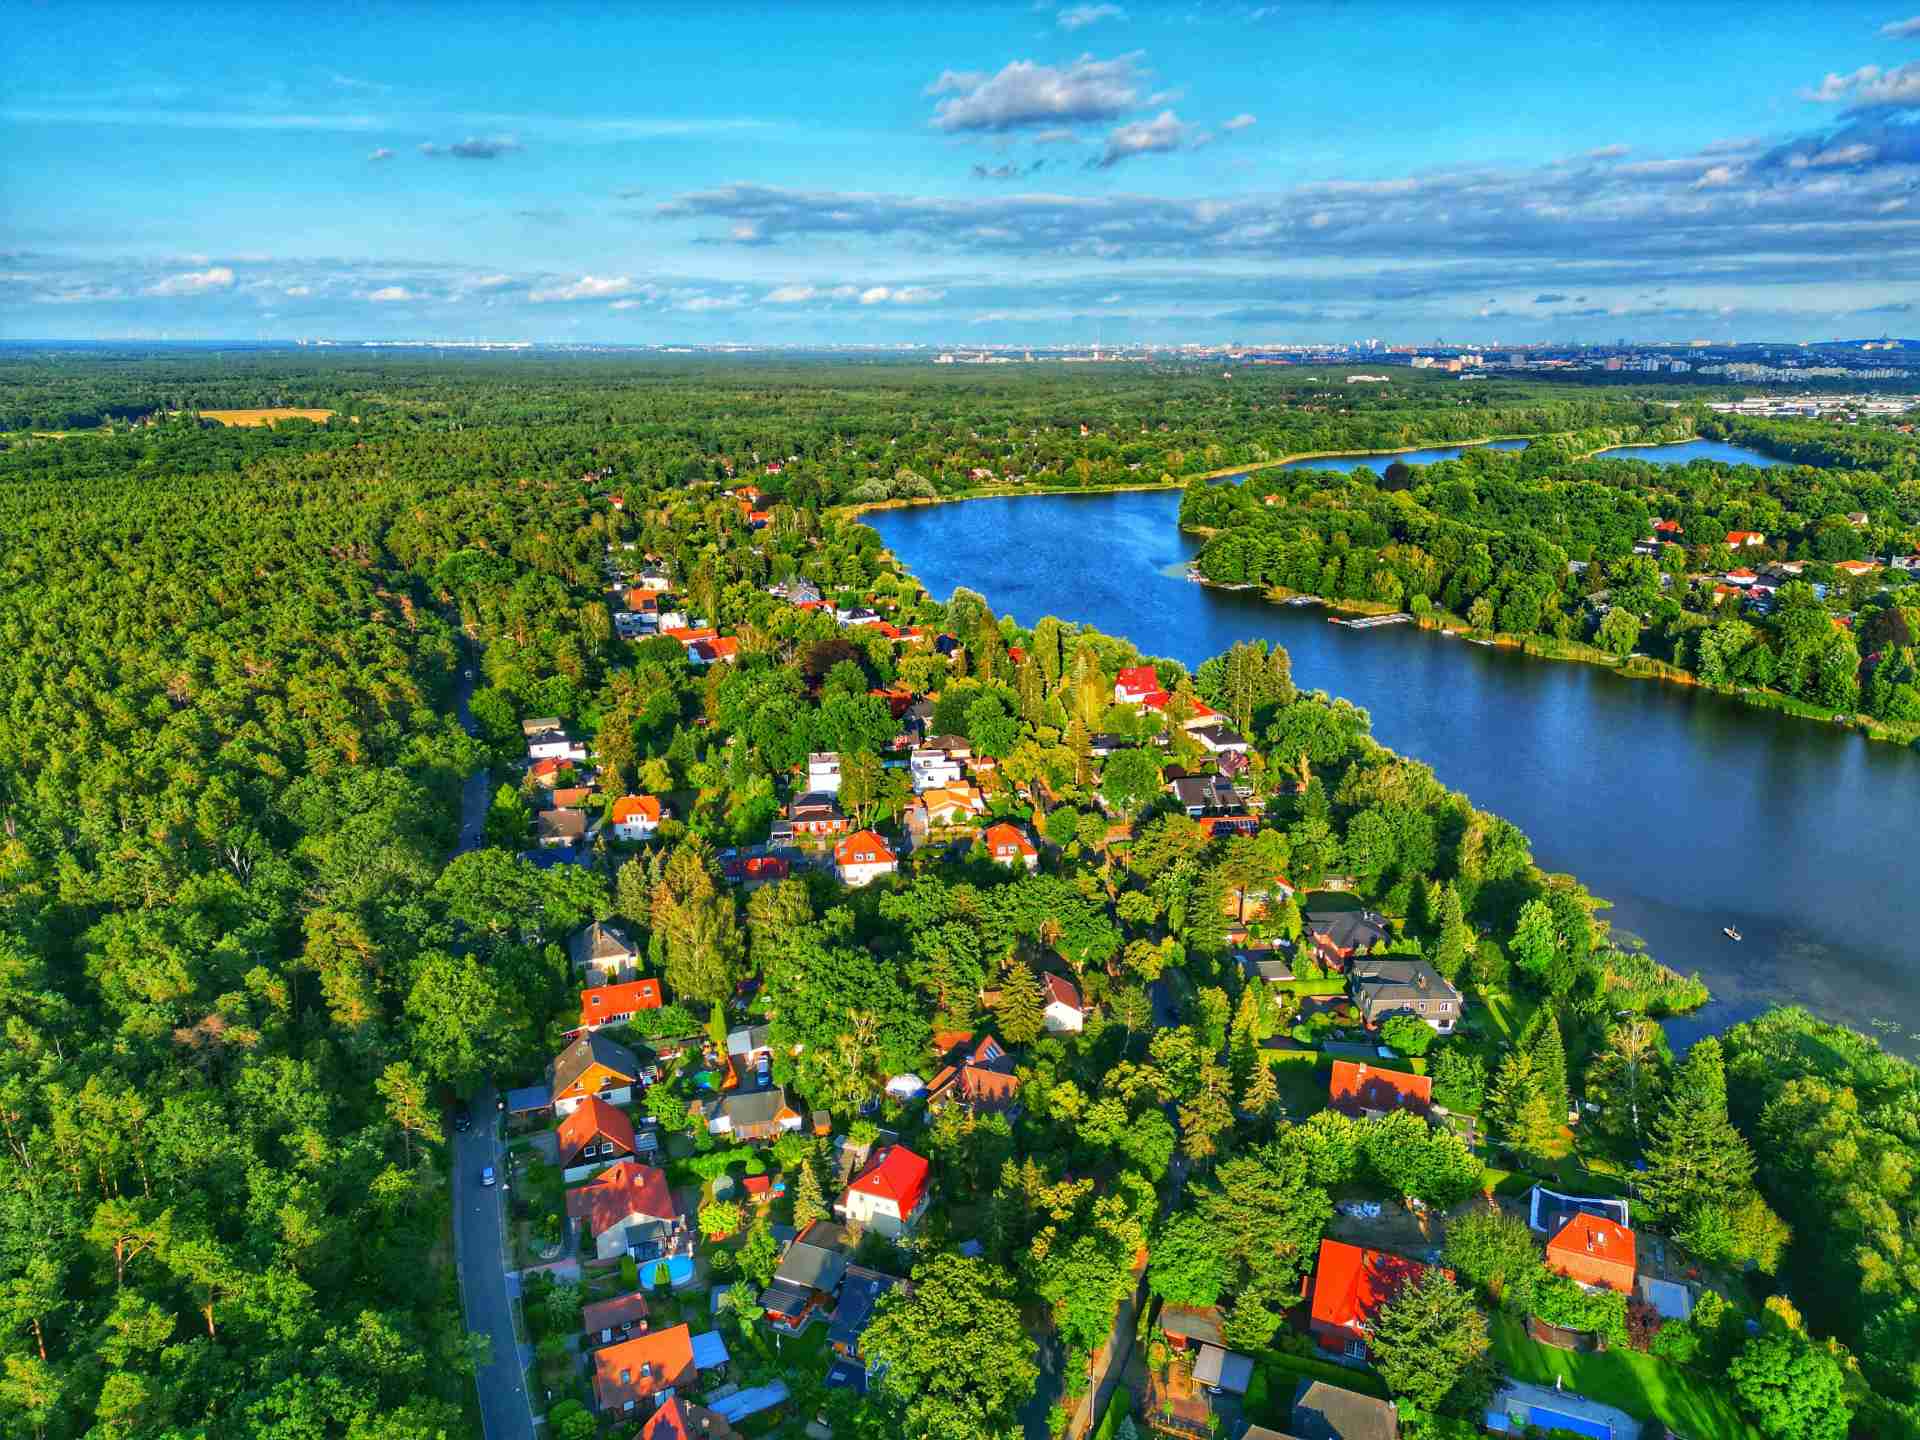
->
[[1181, 417, 1920, 733]]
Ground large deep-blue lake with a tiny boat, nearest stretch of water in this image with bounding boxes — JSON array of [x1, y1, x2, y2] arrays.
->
[[868, 457, 1920, 1052]]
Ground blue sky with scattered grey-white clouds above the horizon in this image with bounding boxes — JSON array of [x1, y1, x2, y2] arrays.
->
[[0, 0, 1920, 346]]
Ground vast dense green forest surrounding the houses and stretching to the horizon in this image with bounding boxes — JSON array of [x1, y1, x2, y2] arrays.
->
[[0, 357, 1920, 1440]]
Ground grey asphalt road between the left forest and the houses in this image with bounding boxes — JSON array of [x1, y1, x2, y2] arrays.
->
[[447, 657, 534, 1440]]
